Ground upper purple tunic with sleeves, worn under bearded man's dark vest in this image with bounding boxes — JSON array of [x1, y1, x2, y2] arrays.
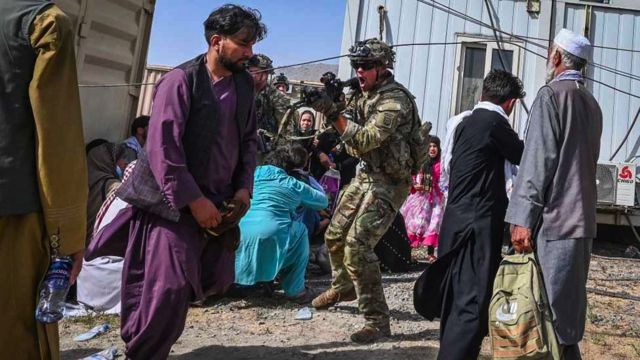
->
[[145, 69, 256, 209]]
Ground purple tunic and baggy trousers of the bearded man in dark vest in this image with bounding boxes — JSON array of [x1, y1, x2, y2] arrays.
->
[[89, 69, 256, 360]]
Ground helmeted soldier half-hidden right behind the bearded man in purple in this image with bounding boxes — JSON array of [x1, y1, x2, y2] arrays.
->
[[247, 54, 297, 156]]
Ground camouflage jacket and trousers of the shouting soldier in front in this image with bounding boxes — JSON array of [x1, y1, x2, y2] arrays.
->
[[325, 73, 416, 329]]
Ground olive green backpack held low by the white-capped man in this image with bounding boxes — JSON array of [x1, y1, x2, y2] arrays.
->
[[489, 253, 561, 360]]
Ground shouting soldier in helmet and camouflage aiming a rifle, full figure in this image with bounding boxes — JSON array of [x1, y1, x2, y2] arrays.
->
[[312, 39, 419, 343]]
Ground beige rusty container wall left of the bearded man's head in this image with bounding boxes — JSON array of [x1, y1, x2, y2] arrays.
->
[[54, 0, 155, 142]]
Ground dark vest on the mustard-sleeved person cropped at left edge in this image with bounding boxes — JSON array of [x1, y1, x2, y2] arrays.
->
[[0, 0, 53, 216]]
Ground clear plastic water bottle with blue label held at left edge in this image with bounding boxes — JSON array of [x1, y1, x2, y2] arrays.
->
[[36, 256, 73, 324]]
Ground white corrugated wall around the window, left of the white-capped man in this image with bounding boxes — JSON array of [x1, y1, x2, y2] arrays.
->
[[339, 0, 549, 136]]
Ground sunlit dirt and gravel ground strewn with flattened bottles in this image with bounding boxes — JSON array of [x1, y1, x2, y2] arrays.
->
[[60, 244, 640, 360]]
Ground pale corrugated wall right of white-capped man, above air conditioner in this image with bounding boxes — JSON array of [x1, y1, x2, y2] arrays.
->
[[564, 5, 640, 161]]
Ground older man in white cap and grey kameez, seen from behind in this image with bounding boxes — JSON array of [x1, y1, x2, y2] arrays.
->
[[505, 29, 602, 359]]
